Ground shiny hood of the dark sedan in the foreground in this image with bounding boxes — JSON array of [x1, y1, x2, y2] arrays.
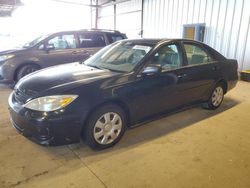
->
[[15, 63, 118, 97]]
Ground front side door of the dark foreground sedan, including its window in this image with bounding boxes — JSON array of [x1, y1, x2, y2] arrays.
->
[[131, 43, 185, 121]]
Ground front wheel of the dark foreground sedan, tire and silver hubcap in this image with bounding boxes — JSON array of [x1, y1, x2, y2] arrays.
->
[[83, 104, 126, 150]]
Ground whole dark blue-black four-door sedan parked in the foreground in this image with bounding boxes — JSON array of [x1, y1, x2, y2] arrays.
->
[[9, 39, 238, 149]]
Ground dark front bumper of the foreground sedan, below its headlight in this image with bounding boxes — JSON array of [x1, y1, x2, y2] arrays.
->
[[9, 93, 81, 146]]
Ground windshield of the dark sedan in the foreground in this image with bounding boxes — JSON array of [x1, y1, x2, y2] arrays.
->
[[84, 41, 152, 72]]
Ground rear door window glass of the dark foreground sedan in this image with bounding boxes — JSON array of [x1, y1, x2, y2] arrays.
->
[[184, 44, 213, 65]]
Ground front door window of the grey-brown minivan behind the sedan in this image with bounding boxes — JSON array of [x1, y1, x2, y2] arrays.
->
[[48, 34, 76, 50]]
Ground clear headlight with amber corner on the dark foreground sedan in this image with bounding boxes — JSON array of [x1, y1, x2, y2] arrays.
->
[[23, 95, 78, 112]]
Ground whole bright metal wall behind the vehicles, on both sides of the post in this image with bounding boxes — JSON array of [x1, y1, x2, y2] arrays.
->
[[98, 0, 250, 70]]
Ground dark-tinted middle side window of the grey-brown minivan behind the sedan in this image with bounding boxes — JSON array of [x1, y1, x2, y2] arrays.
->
[[78, 34, 106, 48]]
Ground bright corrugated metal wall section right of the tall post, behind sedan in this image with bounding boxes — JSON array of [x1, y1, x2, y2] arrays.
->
[[143, 0, 250, 69]]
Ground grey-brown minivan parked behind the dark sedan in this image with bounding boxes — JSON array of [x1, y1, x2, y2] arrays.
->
[[0, 29, 127, 83]]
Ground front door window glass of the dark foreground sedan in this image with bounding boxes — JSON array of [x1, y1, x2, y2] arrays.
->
[[149, 44, 181, 70]]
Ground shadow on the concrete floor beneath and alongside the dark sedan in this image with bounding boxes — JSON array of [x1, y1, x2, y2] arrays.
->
[[42, 97, 240, 163]]
